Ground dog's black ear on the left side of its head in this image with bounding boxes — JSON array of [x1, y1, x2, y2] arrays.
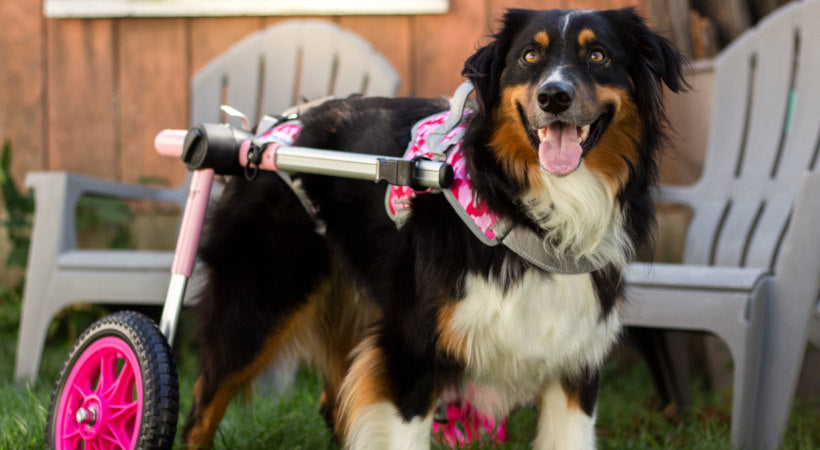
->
[[461, 9, 534, 114]]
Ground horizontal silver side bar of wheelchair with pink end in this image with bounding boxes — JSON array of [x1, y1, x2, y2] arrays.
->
[[154, 124, 453, 188]]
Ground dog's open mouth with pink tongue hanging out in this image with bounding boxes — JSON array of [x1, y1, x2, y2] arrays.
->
[[528, 111, 611, 176]]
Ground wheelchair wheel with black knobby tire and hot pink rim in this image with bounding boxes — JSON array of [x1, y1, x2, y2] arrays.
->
[[45, 311, 179, 449]]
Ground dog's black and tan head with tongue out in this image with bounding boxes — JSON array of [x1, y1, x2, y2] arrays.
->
[[464, 8, 686, 190]]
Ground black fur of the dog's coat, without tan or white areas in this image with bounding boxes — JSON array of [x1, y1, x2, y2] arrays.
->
[[186, 9, 686, 446]]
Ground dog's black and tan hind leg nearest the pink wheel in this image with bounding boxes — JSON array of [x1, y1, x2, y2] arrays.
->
[[183, 174, 329, 447]]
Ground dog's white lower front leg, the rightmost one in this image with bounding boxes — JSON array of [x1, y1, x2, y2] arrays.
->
[[534, 371, 598, 450]]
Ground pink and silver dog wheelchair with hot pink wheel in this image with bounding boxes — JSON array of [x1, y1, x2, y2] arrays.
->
[[45, 107, 468, 449]]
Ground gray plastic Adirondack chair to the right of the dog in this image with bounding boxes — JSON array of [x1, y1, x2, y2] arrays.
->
[[625, 0, 820, 448]]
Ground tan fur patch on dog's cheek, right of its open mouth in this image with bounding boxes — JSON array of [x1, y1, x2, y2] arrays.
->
[[584, 87, 642, 195]]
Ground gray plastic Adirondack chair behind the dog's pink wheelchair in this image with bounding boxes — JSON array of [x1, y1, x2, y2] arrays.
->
[[14, 20, 399, 379]]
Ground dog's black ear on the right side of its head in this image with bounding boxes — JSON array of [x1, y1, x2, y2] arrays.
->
[[620, 8, 691, 92]]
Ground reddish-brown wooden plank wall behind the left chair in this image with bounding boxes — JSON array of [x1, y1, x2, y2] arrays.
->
[[0, 0, 644, 183]]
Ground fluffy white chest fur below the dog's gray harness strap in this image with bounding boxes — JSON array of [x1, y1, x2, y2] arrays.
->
[[450, 270, 621, 413]]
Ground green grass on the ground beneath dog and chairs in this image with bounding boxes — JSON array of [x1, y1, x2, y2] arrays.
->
[[0, 298, 820, 450]]
